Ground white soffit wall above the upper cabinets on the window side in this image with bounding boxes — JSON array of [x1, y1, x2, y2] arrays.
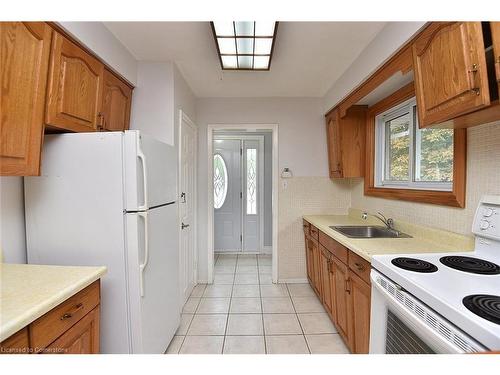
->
[[323, 22, 425, 113]]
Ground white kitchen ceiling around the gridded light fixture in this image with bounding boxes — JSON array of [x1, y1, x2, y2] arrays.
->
[[105, 22, 385, 97]]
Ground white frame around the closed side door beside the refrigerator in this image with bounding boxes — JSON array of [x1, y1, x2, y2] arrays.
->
[[177, 109, 198, 303]]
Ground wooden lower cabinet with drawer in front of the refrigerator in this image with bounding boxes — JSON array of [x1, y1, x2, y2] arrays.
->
[[0, 280, 100, 354]]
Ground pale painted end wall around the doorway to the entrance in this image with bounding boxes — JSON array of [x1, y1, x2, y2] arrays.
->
[[196, 98, 328, 281]]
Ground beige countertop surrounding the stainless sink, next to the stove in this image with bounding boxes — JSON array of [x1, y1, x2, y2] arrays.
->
[[304, 210, 474, 261]]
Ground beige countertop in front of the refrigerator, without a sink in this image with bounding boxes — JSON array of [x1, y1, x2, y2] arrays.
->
[[0, 263, 106, 341]]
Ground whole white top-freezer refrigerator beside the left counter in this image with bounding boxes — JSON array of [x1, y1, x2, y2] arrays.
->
[[24, 130, 181, 353]]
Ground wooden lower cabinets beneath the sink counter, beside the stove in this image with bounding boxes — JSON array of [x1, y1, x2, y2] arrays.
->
[[306, 225, 371, 354]]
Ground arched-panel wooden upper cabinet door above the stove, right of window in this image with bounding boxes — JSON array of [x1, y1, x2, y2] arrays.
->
[[412, 22, 490, 127]]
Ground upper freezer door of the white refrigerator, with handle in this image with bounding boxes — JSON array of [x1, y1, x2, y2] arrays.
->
[[124, 130, 177, 211]]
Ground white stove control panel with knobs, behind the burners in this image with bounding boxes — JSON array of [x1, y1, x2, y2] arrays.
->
[[472, 195, 500, 240]]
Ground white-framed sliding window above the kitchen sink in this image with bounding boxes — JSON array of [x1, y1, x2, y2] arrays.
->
[[375, 98, 453, 191]]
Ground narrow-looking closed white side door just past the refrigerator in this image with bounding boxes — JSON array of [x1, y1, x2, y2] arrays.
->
[[179, 118, 197, 302]]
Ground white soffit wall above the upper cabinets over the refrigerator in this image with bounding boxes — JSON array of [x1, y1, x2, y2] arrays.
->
[[58, 22, 137, 85]]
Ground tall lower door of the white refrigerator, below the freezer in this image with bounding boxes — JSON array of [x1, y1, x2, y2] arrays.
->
[[125, 204, 180, 354]]
